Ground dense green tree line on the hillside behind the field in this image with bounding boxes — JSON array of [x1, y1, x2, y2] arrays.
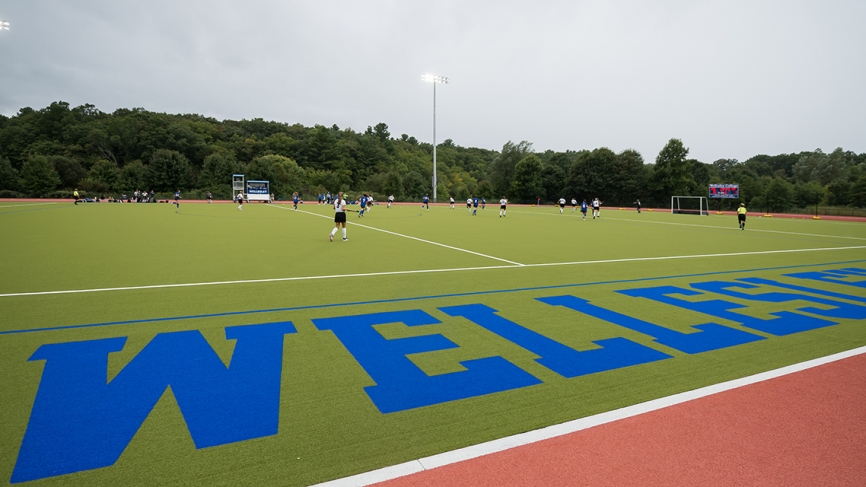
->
[[0, 101, 866, 211]]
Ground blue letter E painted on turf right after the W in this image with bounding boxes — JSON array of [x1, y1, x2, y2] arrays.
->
[[313, 310, 541, 413]]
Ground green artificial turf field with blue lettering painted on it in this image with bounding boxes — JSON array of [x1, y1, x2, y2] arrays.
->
[[0, 203, 866, 485]]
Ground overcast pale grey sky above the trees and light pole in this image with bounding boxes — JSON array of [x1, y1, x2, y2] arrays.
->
[[0, 0, 866, 162]]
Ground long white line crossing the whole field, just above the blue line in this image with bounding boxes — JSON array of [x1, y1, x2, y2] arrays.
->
[[0, 245, 866, 298]]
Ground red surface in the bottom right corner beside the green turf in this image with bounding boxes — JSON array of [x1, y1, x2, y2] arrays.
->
[[376, 354, 866, 487]]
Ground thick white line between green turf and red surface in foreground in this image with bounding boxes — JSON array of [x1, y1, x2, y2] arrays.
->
[[313, 347, 866, 487]]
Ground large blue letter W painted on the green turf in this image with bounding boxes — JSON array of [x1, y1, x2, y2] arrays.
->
[[11, 322, 295, 483]]
